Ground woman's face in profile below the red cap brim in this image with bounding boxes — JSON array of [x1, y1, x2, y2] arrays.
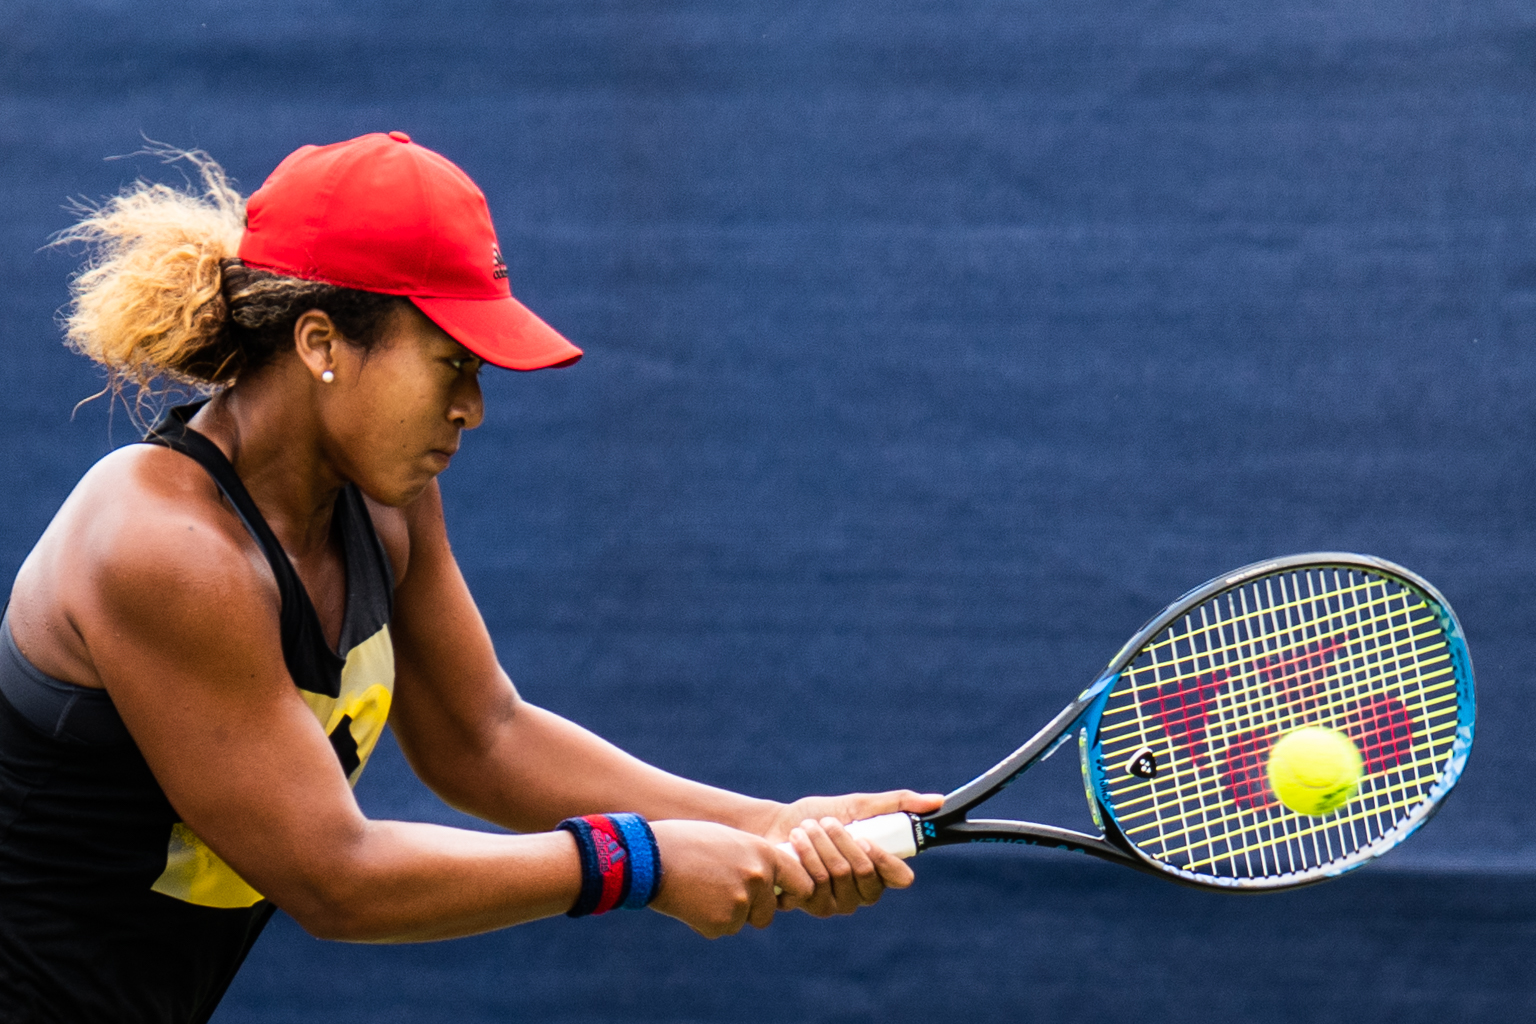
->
[[319, 301, 485, 507]]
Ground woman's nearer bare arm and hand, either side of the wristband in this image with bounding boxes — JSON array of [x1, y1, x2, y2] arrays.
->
[[68, 460, 811, 941]]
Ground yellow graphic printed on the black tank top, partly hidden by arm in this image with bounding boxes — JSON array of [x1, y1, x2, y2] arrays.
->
[[151, 626, 395, 907]]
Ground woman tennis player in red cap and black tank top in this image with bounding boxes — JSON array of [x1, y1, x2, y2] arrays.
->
[[0, 132, 937, 1024]]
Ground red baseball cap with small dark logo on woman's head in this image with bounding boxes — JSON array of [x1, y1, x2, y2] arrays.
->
[[240, 132, 581, 370]]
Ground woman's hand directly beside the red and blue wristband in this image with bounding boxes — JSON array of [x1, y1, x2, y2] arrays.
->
[[651, 820, 816, 938]]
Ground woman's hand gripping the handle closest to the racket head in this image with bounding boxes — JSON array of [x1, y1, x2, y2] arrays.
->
[[763, 789, 943, 917]]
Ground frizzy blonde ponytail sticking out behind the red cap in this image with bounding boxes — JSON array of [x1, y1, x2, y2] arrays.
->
[[55, 149, 246, 388]]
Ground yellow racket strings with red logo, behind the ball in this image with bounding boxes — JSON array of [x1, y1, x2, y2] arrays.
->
[[1098, 568, 1458, 878]]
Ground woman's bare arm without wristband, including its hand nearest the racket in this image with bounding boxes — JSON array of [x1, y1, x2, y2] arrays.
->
[[390, 485, 938, 913]]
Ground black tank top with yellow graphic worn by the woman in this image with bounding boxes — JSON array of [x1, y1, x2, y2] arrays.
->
[[0, 405, 395, 1024]]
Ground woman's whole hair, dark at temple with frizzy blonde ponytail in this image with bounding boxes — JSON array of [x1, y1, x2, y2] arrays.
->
[[54, 146, 402, 391]]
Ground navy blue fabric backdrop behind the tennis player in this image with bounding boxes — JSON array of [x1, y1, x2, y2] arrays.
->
[[0, 0, 1536, 1024]]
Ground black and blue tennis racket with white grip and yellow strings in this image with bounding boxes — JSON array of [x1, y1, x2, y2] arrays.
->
[[817, 553, 1476, 890]]
